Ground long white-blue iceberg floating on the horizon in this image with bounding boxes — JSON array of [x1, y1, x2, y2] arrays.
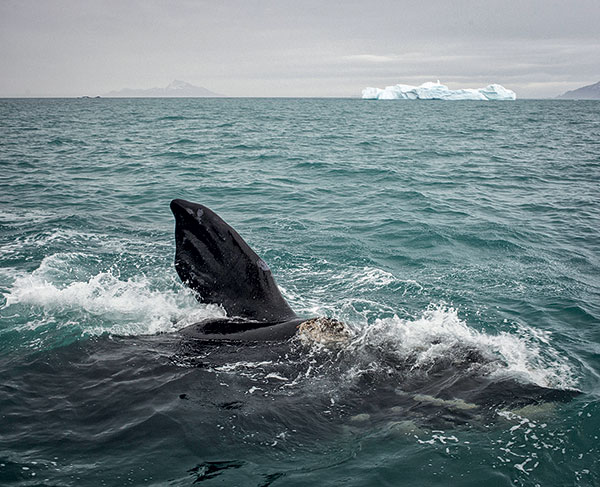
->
[[362, 81, 517, 100]]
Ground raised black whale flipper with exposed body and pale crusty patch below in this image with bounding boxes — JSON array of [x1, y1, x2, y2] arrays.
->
[[170, 199, 351, 342]]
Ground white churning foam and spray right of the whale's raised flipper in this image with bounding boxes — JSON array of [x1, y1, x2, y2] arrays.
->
[[264, 263, 577, 389]]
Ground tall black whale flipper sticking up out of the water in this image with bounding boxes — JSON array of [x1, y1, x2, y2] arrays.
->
[[171, 199, 296, 323]]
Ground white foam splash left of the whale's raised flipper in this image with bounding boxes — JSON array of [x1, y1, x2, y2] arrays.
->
[[4, 254, 224, 335]]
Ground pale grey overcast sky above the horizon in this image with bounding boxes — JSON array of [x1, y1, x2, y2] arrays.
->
[[0, 0, 600, 97]]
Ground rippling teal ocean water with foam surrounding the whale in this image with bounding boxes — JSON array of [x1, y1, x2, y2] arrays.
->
[[0, 99, 600, 486]]
